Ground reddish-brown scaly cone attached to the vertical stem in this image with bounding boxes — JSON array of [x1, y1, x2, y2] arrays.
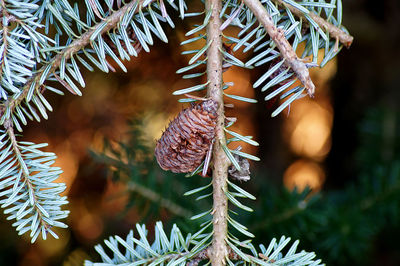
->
[[155, 100, 218, 173]]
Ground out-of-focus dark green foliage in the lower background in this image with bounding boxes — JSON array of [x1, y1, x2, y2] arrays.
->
[[95, 107, 400, 265]]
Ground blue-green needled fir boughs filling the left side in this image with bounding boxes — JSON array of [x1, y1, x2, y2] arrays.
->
[[0, 0, 173, 242]]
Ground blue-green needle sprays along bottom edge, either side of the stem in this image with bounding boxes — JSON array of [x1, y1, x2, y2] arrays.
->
[[85, 222, 321, 265]]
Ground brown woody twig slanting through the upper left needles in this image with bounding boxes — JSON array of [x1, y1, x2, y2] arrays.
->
[[0, 0, 152, 117]]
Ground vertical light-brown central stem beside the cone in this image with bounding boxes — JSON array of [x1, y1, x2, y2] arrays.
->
[[205, 0, 230, 265]]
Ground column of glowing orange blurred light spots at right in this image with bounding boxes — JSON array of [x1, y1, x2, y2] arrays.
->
[[284, 54, 337, 190]]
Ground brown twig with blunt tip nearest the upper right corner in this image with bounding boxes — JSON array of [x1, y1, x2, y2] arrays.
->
[[274, 0, 354, 48]]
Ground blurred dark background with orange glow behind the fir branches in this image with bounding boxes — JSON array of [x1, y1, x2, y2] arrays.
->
[[0, 0, 400, 265]]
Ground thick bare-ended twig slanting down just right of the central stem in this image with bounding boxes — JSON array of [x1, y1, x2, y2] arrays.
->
[[243, 0, 315, 97]]
